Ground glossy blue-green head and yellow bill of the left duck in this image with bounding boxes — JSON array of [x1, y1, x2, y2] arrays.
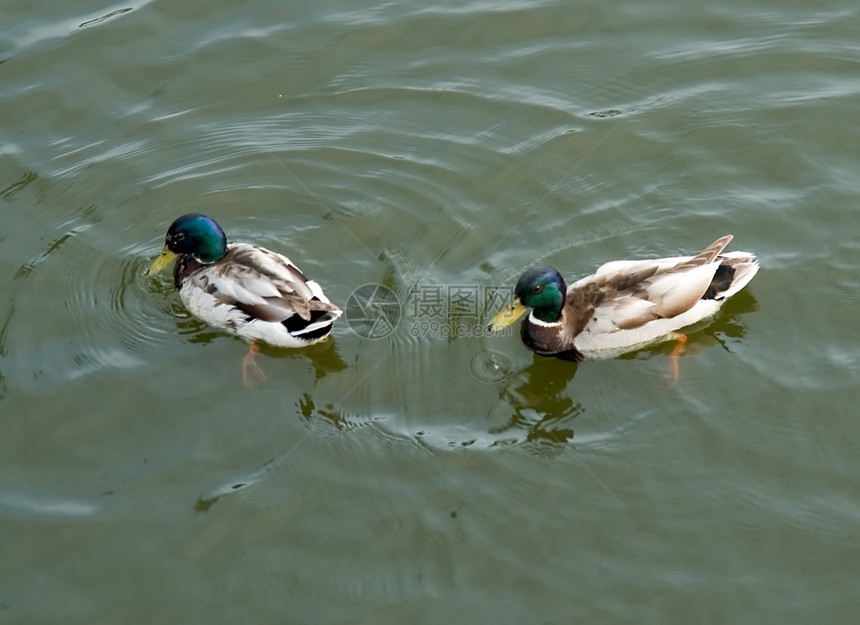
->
[[147, 213, 227, 276]]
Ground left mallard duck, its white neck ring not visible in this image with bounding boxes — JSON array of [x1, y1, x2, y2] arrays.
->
[[147, 213, 342, 380]]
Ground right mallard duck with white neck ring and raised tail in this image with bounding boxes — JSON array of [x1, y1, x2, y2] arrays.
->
[[489, 235, 759, 361]]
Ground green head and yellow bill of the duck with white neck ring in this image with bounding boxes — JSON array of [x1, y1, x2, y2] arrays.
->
[[490, 267, 567, 331]]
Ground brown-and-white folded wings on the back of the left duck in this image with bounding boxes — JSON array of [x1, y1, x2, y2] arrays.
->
[[191, 243, 341, 322]]
